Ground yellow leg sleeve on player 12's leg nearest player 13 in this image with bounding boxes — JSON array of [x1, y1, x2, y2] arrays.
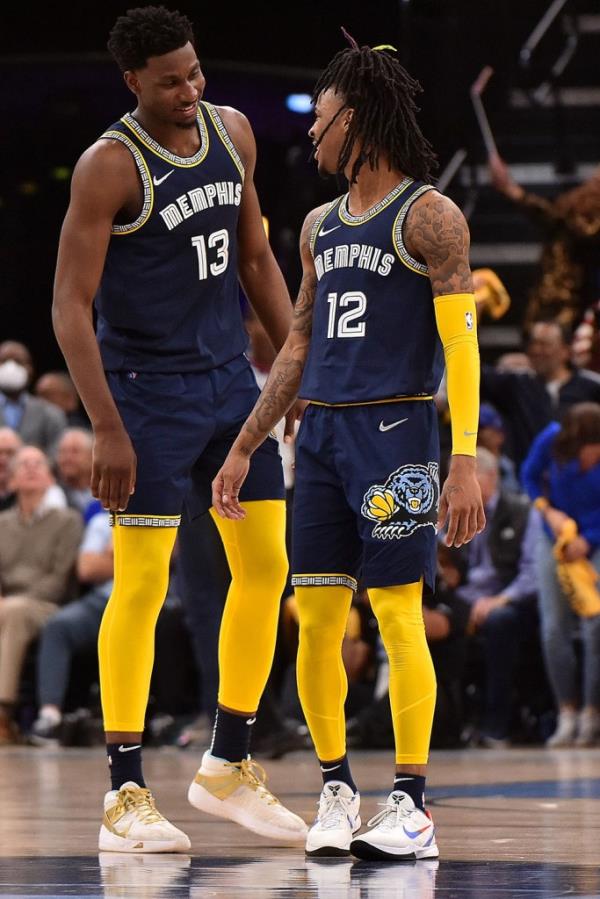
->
[[296, 586, 352, 762]]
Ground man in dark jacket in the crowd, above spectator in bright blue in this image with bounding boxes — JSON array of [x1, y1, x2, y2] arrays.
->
[[481, 321, 600, 469]]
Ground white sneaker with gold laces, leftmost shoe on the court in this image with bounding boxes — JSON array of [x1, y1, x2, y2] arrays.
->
[[98, 780, 191, 852]]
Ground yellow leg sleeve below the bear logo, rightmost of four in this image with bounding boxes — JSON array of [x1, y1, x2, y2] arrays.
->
[[369, 580, 436, 765]]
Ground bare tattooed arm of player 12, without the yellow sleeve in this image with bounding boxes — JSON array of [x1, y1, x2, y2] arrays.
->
[[212, 206, 325, 519]]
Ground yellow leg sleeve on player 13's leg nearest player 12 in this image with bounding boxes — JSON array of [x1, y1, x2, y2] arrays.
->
[[211, 500, 288, 713]]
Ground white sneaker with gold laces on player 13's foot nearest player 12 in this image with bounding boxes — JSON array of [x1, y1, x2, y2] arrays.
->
[[188, 751, 308, 843]]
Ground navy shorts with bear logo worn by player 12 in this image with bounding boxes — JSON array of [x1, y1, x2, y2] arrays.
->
[[292, 400, 439, 589]]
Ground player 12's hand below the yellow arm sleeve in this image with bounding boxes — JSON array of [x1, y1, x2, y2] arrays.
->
[[437, 455, 485, 546]]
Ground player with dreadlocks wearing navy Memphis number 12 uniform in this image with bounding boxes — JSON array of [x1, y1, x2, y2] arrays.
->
[[213, 40, 485, 861]]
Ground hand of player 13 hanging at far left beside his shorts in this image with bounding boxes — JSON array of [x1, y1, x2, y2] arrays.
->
[[90, 425, 137, 512]]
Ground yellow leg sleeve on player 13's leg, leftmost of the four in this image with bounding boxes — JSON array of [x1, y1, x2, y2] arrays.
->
[[98, 523, 177, 733]]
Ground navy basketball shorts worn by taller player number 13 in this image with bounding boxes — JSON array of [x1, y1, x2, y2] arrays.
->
[[106, 356, 285, 527]]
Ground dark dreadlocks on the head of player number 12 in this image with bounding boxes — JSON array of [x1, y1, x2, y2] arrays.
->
[[312, 38, 437, 183]]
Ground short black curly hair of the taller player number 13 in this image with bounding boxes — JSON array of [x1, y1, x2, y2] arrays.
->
[[107, 6, 194, 72]]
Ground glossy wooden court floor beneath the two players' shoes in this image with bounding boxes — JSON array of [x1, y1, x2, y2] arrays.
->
[[0, 748, 600, 899]]
